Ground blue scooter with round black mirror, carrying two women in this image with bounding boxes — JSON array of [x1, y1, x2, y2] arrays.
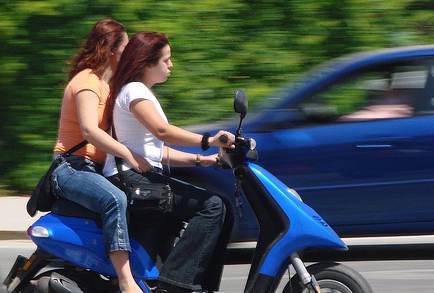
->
[[3, 91, 373, 293]]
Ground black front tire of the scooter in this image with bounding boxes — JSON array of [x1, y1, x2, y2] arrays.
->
[[283, 263, 373, 293]]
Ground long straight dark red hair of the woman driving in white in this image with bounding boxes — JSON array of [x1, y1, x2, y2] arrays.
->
[[110, 32, 169, 104]]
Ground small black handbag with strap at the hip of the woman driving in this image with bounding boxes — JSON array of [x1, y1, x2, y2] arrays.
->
[[112, 126, 173, 216]]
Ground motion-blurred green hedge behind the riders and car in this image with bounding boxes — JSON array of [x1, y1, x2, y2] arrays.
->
[[0, 0, 434, 193]]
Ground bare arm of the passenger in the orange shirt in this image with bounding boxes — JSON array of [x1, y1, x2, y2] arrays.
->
[[76, 90, 152, 172]]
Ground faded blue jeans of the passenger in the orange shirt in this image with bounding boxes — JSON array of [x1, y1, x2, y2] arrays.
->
[[51, 155, 131, 255]]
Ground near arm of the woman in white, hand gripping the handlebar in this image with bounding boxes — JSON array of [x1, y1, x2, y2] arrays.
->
[[130, 99, 235, 148]]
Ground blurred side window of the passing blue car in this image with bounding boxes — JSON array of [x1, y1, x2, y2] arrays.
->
[[295, 58, 434, 124]]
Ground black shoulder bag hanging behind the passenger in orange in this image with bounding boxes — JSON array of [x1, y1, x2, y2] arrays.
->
[[26, 140, 87, 217]]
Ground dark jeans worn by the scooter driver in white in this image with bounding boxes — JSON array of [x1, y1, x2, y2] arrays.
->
[[111, 170, 233, 291]]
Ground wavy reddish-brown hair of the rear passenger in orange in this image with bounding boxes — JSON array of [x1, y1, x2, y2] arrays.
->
[[68, 18, 126, 80]]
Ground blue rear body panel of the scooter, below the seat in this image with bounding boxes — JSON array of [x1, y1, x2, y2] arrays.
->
[[30, 213, 159, 279]]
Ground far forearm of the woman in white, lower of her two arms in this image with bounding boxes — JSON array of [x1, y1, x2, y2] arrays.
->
[[163, 146, 218, 167]]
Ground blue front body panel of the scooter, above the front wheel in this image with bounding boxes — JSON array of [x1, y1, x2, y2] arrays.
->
[[247, 163, 348, 276]]
